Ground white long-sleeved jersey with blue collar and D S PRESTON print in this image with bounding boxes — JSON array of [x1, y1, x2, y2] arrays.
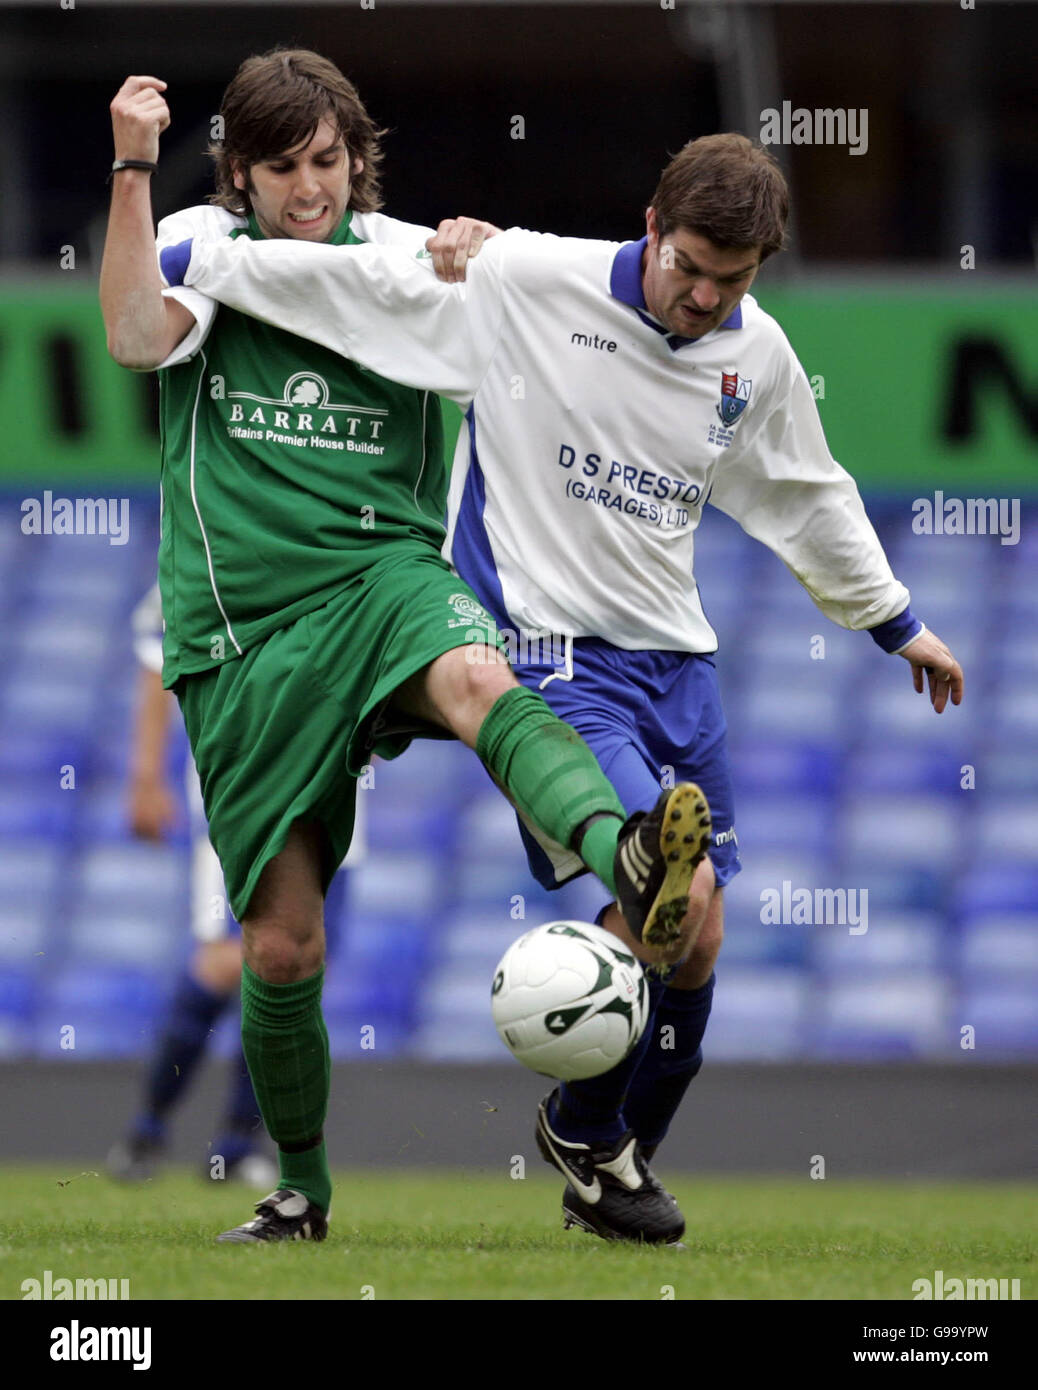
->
[[185, 229, 909, 652]]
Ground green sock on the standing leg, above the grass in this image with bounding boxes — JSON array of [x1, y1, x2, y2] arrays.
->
[[242, 965, 332, 1212]]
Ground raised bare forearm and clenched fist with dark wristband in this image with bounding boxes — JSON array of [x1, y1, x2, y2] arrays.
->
[[100, 76, 195, 371]]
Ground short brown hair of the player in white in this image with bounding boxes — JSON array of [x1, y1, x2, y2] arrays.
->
[[650, 135, 789, 261]]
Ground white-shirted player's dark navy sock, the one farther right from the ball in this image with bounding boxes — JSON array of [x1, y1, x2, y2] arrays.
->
[[624, 974, 714, 1147]]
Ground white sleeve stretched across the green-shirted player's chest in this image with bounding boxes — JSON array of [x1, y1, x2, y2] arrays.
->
[[185, 235, 507, 406]]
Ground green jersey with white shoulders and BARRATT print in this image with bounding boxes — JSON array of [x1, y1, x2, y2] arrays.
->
[[158, 207, 447, 687]]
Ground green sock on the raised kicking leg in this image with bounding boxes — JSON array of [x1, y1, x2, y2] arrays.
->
[[475, 685, 627, 892]]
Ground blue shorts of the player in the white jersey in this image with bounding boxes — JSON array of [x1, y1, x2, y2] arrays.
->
[[513, 637, 742, 888]]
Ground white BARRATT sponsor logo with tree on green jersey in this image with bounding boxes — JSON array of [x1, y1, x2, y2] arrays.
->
[[223, 371, 389, 453]]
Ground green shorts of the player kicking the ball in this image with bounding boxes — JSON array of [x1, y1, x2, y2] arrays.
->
[[175, 555, 504, 920]]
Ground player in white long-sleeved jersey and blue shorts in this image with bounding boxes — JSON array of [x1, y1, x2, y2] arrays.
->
[[162, 127, 963, 1241]]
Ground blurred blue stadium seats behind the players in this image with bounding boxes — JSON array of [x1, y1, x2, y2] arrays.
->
[[0, 495, 1038, 1065]]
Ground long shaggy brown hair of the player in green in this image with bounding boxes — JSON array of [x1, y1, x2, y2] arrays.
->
[[208, 49, 386, 214]]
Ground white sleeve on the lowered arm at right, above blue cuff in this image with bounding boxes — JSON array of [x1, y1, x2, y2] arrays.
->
[[709, 339, 909, 630]]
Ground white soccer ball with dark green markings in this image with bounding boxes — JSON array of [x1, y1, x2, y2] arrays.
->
[[491, 922, 649, 1081]]
